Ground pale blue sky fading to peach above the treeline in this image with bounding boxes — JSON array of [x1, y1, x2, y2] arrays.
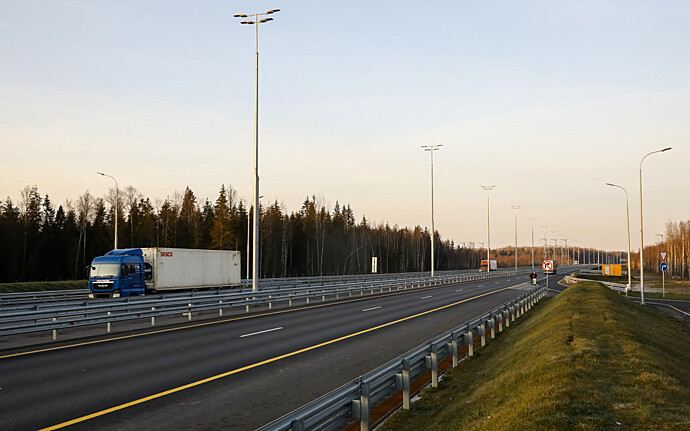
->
[[0, 0, 690, 250]]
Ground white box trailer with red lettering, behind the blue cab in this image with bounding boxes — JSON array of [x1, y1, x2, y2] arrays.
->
[[141, 247, 240, 292]]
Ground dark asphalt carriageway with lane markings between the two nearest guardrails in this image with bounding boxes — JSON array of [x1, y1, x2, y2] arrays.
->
[[0, 274, 561, 430]]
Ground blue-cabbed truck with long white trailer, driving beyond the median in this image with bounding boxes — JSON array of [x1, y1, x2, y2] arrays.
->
[[89, 247, 240, 298]]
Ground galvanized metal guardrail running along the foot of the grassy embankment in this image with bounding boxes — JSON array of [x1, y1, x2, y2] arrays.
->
[[259, 286, 546, 431]]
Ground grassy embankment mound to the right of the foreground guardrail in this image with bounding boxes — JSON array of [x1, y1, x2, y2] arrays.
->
[[383, 282, 690, 431]]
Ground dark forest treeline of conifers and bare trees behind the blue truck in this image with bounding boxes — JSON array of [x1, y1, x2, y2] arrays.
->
[[0, 186, 494, 282]]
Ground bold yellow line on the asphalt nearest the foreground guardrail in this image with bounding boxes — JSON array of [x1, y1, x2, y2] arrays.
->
[[39, 286, 513, 431]]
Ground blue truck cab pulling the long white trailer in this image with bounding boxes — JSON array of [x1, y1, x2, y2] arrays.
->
[[89, 248, 150, 298]]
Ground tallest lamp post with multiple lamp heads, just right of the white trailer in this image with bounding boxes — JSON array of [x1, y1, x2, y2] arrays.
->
[[233, 9, 280, 292]]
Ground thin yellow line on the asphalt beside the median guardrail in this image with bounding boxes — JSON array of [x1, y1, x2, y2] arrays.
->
[[0, 278, 500, 359]]
